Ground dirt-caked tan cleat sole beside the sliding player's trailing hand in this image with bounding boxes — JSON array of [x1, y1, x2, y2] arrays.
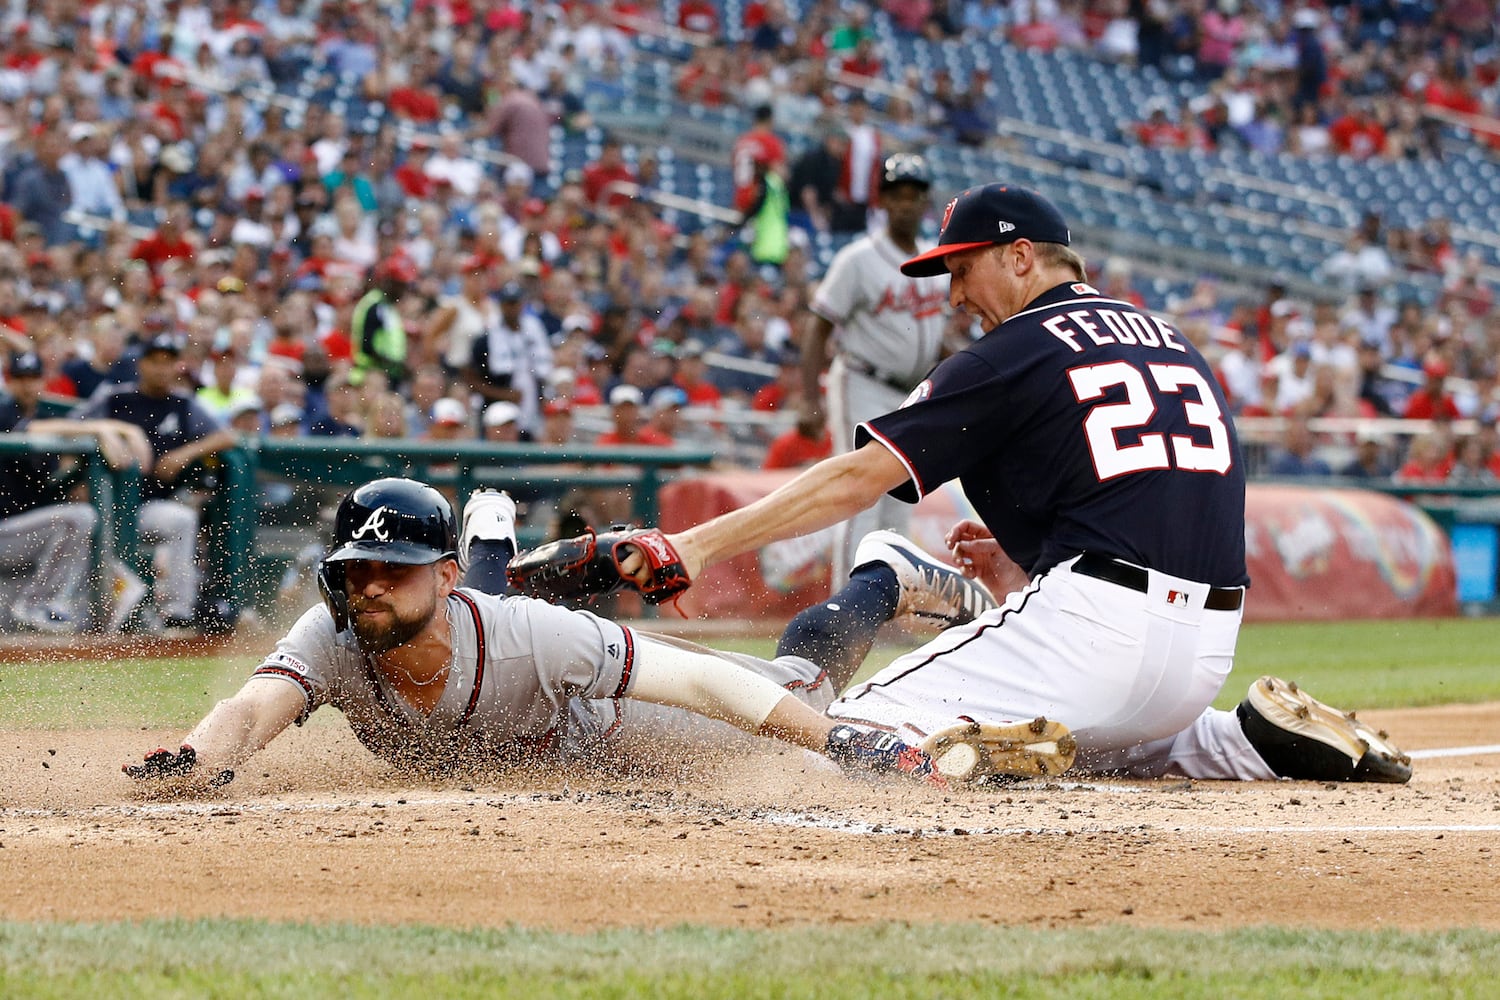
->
[[921, 717, 1079, 784]]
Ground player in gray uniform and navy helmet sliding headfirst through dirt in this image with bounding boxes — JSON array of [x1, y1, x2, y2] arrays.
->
[[125, 478, 1044, 790]]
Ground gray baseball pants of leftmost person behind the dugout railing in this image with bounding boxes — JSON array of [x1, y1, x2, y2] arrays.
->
[[0, 504, 99, 625]]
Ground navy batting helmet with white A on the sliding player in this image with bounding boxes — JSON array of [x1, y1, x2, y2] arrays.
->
[[318, 478, 459, 631]]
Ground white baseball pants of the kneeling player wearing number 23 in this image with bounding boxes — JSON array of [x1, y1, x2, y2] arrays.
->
[[828, 561, 1275, 778]]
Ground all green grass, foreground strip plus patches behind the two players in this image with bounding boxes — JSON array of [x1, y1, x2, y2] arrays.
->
[[0, 619, 1500, 1000]]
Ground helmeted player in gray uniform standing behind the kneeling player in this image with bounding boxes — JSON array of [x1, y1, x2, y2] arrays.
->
[[803, 153, 947, 589]]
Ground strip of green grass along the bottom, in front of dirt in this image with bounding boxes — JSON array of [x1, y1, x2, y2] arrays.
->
[[0, 921, 1500, 1000]]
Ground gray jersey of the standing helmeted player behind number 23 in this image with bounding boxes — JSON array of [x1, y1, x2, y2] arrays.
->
[[812, 231, 948, 389]]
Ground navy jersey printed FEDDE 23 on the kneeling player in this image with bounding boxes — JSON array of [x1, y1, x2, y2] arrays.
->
[[857, 282, 1248, 586]]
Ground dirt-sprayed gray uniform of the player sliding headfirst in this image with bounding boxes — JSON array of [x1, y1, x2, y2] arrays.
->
[[255, 588, 833, 765]]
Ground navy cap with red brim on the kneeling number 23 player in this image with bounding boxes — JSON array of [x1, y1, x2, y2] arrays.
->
[[902, 184, 1073, 277]]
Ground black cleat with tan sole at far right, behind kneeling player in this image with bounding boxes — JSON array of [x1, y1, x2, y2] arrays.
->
[[1236, 676, 1412, 784]]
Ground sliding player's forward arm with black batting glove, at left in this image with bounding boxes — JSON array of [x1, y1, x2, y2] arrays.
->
[[125, 678, 308, 792]]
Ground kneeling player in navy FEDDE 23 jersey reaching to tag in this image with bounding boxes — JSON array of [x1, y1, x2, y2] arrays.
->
[[621, 184, 1410, 781]]
